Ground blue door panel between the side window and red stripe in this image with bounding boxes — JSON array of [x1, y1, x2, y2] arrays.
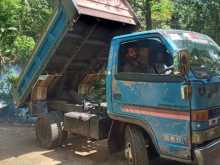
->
[[115, 80, 189, 111]]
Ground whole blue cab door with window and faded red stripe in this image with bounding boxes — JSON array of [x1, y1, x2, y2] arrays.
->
[[111, 34, 191, 160]]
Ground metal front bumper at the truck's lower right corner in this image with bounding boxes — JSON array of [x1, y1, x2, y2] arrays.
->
[[194, 139, 220, 165]]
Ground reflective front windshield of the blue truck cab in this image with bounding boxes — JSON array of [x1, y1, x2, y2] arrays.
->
[[166, 31, 220, 78]]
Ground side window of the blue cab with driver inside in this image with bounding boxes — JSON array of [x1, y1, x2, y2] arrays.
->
[[118, 38, 173, 75]]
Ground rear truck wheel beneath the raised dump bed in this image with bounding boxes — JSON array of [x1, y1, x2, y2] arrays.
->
[[36, 112, 67, 149]]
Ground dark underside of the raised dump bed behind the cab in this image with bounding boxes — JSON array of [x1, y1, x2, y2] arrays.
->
[[44, 16, 134, 103]]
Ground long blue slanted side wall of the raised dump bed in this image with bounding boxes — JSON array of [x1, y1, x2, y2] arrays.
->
[[15, 1, 72, 103]]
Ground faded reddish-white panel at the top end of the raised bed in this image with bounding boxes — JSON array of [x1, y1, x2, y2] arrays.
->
[[75, 0, 138, 25]]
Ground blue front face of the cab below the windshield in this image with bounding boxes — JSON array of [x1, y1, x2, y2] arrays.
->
[[191, 77, 220, 131]]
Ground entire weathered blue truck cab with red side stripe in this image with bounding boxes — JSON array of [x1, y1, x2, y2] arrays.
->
[[106, 30, 220, 164]]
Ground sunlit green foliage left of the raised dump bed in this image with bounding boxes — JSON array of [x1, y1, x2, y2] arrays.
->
[[0, 0, 52, 64]]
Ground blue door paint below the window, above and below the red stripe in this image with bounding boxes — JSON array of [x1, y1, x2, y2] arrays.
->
[[112, 80, 191, 159]]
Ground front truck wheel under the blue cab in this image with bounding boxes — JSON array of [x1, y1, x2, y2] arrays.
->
[[125, 126, 149, 165]]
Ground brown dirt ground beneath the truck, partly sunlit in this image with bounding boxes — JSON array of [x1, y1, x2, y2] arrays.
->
[[0, 123, 182, 165]]
